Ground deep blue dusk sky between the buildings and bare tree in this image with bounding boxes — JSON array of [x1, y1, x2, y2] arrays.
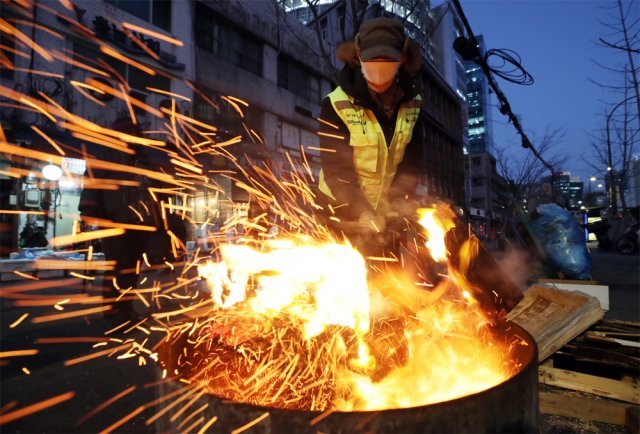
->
[[444, 0, 640, 182]]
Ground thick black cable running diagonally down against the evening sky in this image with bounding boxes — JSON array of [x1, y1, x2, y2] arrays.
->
[[452, 0, 554, 175]]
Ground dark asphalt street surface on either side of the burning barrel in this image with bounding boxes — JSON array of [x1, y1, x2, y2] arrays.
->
[[0, 246, 640, 432]]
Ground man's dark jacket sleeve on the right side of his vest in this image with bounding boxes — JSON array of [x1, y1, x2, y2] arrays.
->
[[389, 111, 424, 201]]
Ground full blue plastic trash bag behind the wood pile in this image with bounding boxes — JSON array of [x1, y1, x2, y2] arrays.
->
[[532, 203, 591, 279]]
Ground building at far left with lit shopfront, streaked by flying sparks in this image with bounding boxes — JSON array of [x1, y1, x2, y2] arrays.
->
[[0, 0, 195, 256]]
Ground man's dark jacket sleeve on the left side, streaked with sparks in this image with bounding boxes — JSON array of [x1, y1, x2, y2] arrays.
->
[[319, 98, 373, 220]]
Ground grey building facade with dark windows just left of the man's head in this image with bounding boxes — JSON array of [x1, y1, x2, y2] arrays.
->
[[193, 1, 332, 227]]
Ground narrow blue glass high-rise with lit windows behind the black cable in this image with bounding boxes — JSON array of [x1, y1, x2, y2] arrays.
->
[[464, 35, 493, 154]]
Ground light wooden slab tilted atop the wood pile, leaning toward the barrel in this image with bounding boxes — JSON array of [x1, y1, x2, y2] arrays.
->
[[507, 285, 604, 361]]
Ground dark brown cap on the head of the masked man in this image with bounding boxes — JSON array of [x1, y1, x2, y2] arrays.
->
[[356, 18, 405, 62]]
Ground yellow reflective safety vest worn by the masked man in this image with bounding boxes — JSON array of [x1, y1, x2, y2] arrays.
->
[[318, 87, 422, 209]]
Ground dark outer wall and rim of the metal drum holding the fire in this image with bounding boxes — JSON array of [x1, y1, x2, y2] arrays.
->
[[156, 322, 539, 434]]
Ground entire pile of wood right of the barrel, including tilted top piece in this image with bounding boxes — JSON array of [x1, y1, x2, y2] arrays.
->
[[508, 285, 640, 432]]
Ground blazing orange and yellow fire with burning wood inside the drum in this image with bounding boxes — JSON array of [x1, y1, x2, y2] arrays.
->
[[186, 209, 517, 411]]
